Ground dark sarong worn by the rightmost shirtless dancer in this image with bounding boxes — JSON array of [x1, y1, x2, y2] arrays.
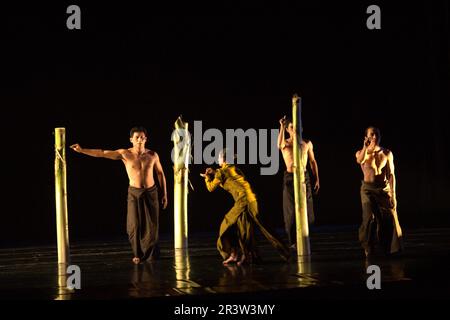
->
[[359, 181, 403, 254]]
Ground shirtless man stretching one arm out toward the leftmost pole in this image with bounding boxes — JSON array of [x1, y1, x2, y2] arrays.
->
[[70, 127, 167, 264]]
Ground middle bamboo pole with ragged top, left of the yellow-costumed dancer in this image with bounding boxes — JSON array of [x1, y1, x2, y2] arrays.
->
[[172, 116, 191, 250]]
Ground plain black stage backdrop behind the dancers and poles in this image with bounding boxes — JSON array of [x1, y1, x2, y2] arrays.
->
[[0, 1, 450, 246]]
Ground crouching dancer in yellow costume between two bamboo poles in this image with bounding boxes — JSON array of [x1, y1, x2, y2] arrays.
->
[[201, 150, 289, 265]]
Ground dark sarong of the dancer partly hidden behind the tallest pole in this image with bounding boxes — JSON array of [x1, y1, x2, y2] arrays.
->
[[283, 171, 314, 246]]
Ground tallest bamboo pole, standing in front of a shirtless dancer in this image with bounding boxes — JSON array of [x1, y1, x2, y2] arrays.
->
[[292, 95, 311, 257]]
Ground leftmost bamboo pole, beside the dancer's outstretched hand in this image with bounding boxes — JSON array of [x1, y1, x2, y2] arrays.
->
[[55, 128, 70, 274]]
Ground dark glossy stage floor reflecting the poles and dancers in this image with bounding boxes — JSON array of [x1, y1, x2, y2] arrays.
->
[[0, 227, 450, 302]]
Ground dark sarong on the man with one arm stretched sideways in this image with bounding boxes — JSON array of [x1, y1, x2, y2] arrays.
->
[[127, 185, 159, 260]]
